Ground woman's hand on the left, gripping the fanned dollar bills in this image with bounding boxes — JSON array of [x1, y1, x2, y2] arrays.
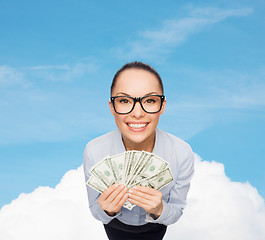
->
[[98, 184, 128, 216]]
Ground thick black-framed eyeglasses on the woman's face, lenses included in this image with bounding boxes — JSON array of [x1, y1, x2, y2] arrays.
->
[[110, 95, 165, 114]]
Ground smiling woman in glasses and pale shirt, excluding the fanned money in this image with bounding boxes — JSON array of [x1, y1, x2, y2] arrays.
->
[[84, 62, 193, 240]]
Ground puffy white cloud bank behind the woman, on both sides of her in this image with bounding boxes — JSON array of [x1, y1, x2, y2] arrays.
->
[[0, 155, 265, 240]]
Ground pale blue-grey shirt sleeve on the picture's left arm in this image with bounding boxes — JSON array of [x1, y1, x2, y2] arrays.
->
[[83, 146, 119, 224]]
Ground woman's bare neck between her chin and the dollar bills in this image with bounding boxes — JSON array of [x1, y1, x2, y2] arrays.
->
[[122, 133, 155, 152]]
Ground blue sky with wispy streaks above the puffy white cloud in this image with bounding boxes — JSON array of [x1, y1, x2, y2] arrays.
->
[[0, 0, 265, 207]]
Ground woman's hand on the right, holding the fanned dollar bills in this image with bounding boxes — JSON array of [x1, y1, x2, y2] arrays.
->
[[128, 186, 163, 218]]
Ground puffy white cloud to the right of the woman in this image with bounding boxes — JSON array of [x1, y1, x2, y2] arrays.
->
[[165, 157, 265, 240]]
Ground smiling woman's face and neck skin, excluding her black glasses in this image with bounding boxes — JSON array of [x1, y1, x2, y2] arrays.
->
[[109, 69, 166, 150]]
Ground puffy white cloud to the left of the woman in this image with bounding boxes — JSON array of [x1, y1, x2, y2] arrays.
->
[[0, 167, 107, 240]]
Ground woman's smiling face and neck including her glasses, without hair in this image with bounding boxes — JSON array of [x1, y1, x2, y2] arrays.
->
[[109, 67, 166, 152]]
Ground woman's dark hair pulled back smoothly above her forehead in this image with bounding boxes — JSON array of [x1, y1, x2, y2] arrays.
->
[[110, 61, 164, 94]]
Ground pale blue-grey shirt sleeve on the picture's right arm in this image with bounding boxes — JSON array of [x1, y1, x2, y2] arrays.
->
[[146, 145, 194, 225]]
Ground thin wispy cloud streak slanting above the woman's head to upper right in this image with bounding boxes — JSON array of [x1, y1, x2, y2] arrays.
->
[[114, 8, 253, 59]]
